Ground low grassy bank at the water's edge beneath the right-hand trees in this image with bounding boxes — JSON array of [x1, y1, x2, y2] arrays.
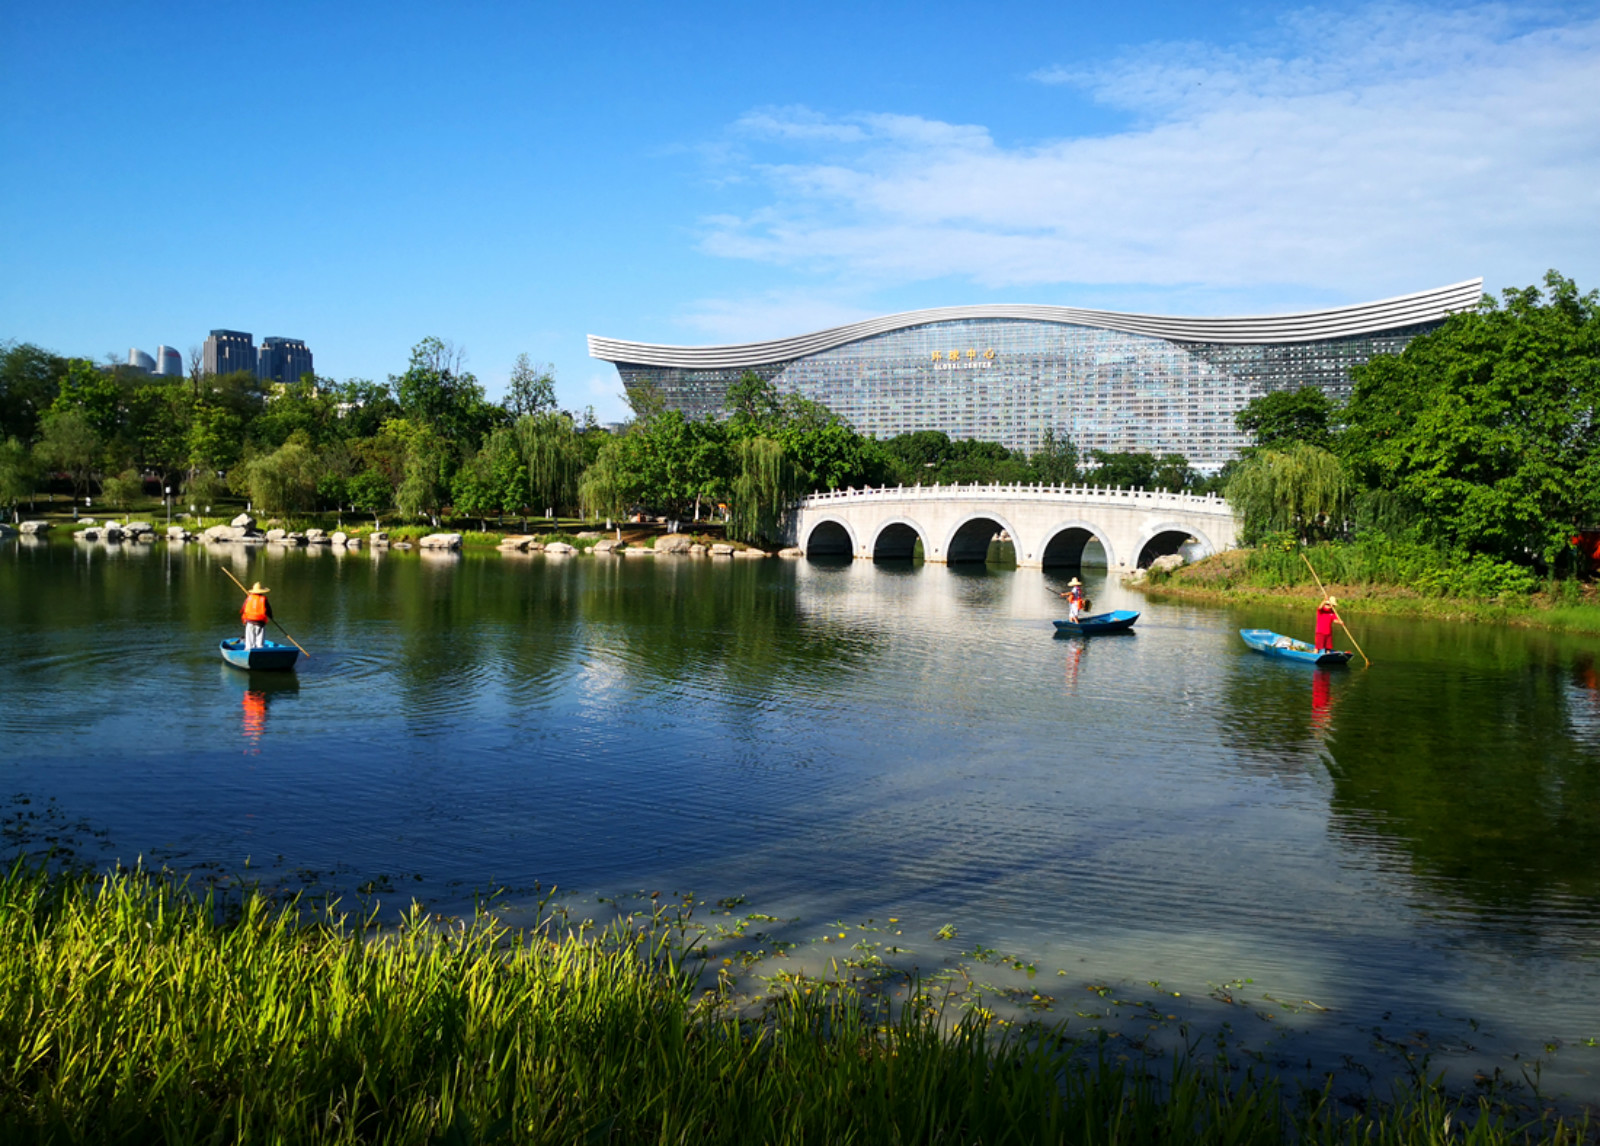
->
[[1134, 541, 1600, 632]]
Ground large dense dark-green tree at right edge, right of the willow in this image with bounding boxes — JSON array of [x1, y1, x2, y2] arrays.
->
[[1341, 270, 1600, 567]]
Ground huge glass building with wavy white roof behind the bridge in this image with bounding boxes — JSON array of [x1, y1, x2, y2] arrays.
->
[[589, 278, 1483, 472]]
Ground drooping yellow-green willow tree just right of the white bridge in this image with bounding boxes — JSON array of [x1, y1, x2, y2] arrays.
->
[[1227, 442, 1350, 543]]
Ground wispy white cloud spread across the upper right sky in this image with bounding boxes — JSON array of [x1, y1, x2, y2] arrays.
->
[[702, 6, 1600, 299]]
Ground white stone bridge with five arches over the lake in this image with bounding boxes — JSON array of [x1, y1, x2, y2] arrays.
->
[[789, 483, 1238, 570]]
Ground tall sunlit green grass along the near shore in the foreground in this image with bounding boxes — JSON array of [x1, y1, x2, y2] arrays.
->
[[0, 866, 1589, 1143]]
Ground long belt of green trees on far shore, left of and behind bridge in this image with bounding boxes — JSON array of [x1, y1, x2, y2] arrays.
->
[[0, 338, 1203, 543]]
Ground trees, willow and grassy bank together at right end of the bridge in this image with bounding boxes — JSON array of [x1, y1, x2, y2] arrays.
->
[[1184, 270, 1600, 608]]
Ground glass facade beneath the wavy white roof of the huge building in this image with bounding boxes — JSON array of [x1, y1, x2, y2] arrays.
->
[[618, 319, 1438, 471]]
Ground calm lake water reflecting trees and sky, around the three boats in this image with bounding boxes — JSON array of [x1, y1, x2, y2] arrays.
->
[[0, 539, 1600, 1101]]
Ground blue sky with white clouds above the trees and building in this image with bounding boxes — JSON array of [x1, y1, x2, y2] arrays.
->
[[0, 0, 1600, 419]]
